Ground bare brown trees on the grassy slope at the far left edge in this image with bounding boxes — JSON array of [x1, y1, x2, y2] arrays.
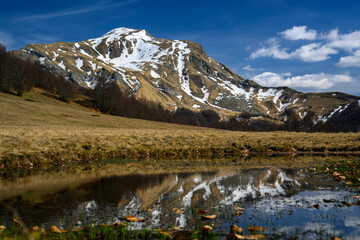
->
[[0, 44, 76, 102]]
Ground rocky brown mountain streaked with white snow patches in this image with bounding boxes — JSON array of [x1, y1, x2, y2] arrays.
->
[[14, 28, 360, 123]]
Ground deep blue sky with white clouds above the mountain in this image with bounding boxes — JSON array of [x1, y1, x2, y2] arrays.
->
[[0, 0, 360, 95]]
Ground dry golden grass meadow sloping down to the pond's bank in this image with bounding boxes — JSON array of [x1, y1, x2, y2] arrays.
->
[[0, 89, 360, 168]]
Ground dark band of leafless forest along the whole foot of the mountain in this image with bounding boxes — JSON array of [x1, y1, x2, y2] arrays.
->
[[0, 44, 360, 132]]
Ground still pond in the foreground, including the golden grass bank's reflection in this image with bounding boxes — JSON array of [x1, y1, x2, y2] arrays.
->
[[0, 157, 360, 239]]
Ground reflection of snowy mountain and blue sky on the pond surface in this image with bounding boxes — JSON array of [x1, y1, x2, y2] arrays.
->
[[0, 167, 360, 238]]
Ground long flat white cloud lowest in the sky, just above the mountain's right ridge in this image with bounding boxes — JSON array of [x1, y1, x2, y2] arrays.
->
[[253, 72, 354, 90]]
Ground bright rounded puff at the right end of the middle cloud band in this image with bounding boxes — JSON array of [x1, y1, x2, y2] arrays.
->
[[290, 43, 338, 62]]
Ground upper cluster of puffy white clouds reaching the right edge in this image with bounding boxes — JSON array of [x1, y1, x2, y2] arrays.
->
[[250, 26, 360, 64]]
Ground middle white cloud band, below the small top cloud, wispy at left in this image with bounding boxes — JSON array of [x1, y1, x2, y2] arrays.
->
[[250, 43, 338, 62]]
